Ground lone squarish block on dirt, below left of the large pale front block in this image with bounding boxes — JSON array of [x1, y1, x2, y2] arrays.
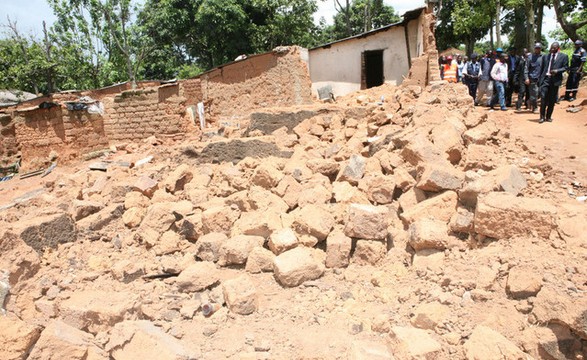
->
[[222, 275, 259, 315]]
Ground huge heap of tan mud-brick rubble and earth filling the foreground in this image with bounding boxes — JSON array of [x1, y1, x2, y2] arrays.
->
[[0, 83, 587, 359]]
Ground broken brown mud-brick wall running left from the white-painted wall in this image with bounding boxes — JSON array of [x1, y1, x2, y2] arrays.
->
[[0, 47, 312, 168]]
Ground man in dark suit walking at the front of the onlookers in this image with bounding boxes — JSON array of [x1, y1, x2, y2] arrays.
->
[[539, 42, 569, 124]]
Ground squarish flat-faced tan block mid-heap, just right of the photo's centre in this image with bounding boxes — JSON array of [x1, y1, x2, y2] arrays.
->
[[344, 204, 390, 240]]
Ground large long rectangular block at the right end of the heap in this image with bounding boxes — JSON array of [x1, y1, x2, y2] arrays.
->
[[475, 192, 556, 239]]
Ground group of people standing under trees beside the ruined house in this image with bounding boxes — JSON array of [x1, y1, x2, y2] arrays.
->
[[439, 40, 587, 123]]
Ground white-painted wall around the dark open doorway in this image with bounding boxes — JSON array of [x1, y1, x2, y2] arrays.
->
[[309, 13, 423, 96]]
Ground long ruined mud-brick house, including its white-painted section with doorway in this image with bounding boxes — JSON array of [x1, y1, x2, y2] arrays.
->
[[0, 8, 436, 176]]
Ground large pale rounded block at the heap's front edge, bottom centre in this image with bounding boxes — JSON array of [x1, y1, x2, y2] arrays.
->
[[273, 247, 325, 287]]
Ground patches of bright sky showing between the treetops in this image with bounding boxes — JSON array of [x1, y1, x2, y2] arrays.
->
[[0, 0, 557, 44]]
